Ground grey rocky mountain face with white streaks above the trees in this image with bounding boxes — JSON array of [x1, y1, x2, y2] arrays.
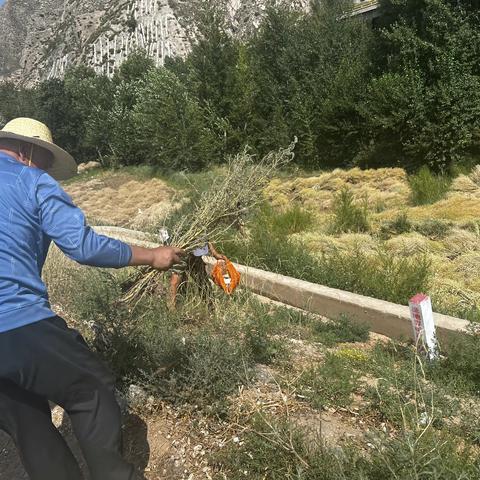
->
[[0, 0, 309, 85]]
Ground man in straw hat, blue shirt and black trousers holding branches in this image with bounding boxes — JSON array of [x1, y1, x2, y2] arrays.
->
[[0, 118, 182, 480]]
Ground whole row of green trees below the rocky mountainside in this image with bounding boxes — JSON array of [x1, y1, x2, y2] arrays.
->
[[0, 0, 480, 171]]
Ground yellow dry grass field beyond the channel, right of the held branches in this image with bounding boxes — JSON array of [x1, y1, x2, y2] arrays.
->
[[266, 166, 480, 315]]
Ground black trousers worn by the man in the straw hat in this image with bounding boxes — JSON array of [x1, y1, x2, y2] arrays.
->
[[0, 317, 137, 480]]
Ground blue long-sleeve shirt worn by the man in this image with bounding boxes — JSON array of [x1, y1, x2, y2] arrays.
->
[[0, 152, 132, 333]]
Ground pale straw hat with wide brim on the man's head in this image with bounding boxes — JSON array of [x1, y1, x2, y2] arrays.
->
[[0, 118, 77, 180]]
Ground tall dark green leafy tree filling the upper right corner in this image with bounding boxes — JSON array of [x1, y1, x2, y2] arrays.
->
[[360, 0, 480, 171]]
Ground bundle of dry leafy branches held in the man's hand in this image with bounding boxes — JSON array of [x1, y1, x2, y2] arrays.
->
[[124, 141, 296, 304]]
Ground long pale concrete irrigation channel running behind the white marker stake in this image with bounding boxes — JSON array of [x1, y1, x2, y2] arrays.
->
[[95, 227, 469, 345]]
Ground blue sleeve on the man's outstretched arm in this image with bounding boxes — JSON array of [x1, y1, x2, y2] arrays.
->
[[36, 174, 132, 268]]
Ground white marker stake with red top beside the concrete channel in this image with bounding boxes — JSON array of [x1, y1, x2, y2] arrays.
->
[[409, 293, 438, 360]]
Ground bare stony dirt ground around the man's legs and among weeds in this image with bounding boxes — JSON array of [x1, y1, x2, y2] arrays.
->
[[0, 376, 367, 480]]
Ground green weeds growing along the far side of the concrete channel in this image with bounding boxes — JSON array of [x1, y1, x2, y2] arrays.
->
[[223, 225, 432, 305]]
